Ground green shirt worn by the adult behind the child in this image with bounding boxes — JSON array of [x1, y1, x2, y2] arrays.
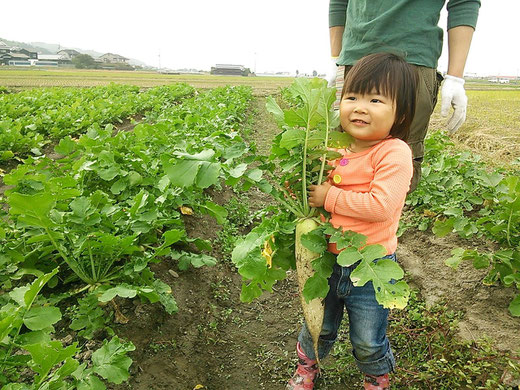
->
[[329, 0, 480, 68]]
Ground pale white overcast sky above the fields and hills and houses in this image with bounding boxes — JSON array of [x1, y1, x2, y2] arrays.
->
[[0, 0, 520, 76]]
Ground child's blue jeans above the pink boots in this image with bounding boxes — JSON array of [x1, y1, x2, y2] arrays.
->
[[298, 253, 396, 375]]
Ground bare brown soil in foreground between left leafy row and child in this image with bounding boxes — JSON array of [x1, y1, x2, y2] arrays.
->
[[112, 248, 299, 390]]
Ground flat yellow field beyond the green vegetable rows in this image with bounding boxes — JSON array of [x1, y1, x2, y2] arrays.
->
[[0, 68, 520, 165]]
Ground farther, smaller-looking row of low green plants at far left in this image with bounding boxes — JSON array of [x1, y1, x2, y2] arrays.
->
[[0, 84, 194, 162]]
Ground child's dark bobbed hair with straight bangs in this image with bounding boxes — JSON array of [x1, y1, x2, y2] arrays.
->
[[341, 53, 418, 141]]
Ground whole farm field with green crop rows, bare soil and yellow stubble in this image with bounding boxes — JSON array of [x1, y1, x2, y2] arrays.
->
[[0, 69, 520, 390]]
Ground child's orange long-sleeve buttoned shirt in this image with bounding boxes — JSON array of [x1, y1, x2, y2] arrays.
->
[[324, 138, 413, 254]]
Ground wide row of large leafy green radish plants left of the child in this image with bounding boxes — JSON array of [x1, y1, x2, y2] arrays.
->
[[0, 84, 260, 390]]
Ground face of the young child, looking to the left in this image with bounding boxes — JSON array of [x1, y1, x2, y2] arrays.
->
[[339, 92, 395, 142]]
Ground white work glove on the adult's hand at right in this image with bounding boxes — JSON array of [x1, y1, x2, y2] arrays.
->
[[441, 74, 468, 133]]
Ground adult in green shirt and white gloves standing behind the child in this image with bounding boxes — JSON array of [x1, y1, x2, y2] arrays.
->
[[327, 0, 480, 192]]
